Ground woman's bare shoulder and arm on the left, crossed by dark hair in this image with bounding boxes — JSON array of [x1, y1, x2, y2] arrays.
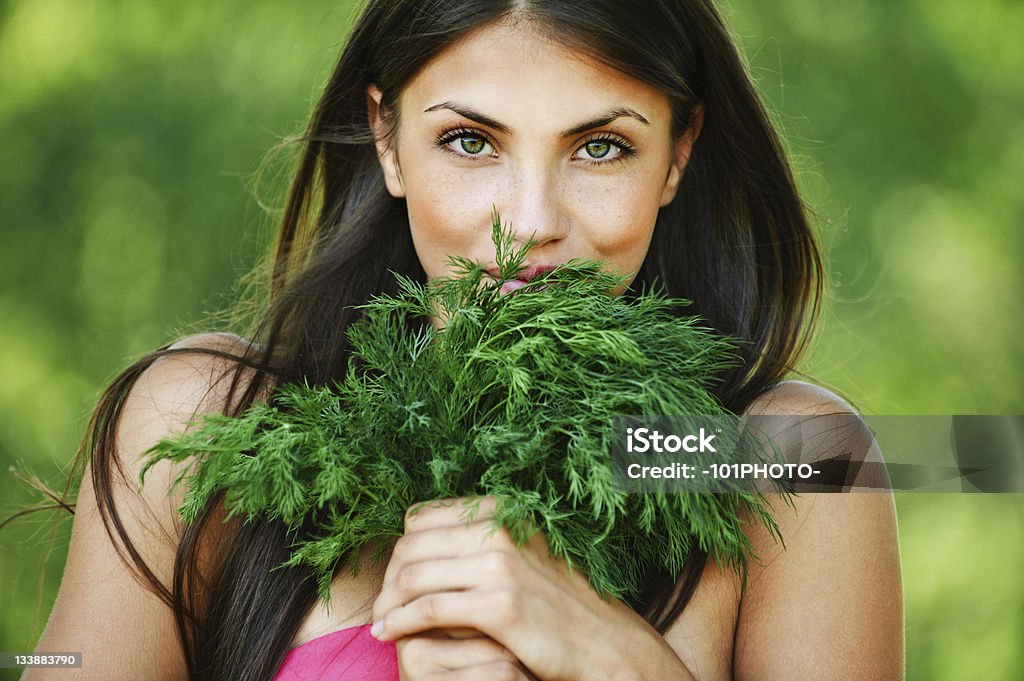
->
[[22, 334, 251, 681]]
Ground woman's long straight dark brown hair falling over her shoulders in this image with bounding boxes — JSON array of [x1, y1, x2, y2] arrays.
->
[[80, 0, 821, 679]]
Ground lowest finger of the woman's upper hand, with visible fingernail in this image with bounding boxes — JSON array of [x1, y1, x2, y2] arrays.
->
[[370, 589, 516, 643]]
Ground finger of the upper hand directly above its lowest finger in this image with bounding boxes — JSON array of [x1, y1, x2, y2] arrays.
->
[[374, 551, 521, 620]]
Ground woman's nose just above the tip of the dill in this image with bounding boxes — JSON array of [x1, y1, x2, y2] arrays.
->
[[499, 167, 568, 248]]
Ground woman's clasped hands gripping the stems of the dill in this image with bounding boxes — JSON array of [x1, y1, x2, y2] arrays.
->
[[373, 497, 664, 681]]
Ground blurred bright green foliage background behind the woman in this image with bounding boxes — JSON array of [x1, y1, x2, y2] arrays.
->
[[0, 0, 1024, 681]]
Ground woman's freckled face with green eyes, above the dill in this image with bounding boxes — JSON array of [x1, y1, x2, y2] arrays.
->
[[368, 23, 695, 292]]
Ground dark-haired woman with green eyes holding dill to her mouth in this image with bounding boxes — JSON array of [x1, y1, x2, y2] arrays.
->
[[25, 0, 902, 680]]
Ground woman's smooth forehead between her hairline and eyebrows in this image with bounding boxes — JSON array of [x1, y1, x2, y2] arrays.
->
[[400, 19, 671, 135]]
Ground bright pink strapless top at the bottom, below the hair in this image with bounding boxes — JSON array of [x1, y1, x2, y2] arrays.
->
[[273, 625, 398, 681]]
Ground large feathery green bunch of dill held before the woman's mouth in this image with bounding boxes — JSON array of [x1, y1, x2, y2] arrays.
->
[[143, 213, 774, 600]]
